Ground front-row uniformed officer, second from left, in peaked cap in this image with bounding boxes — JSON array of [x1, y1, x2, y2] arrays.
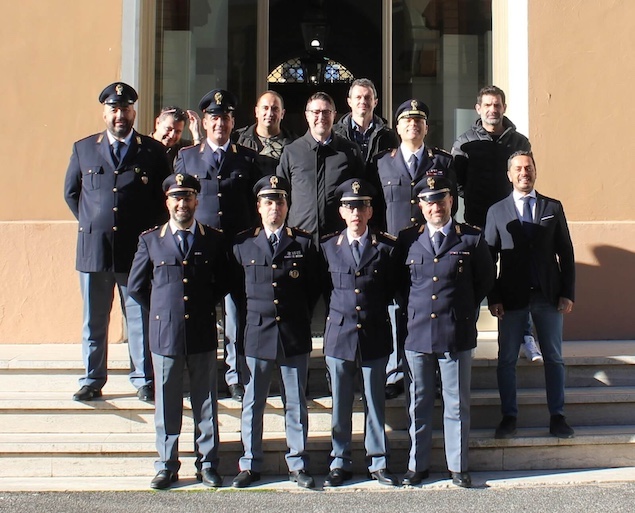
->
[[233, 175, 319, 488]]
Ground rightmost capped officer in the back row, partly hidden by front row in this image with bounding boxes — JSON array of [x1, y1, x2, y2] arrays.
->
[[376, 99, 458, 399]]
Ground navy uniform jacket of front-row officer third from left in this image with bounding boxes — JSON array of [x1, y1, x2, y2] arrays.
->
[[322, 231, 395, 361]]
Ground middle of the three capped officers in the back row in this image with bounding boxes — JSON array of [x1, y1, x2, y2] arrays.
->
[[174, 89, 261, 401]]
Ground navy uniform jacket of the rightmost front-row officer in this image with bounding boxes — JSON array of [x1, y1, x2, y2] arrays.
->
[[397, 222, 495, 353]]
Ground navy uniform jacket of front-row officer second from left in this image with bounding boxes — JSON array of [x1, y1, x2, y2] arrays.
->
[[233, 227, 320, 360]]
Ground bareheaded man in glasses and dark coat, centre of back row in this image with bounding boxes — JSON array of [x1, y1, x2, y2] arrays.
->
[[276, 92, 365, 244]]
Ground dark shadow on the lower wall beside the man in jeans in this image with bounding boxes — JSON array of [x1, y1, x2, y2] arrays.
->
[[564, 246, 635, 340]]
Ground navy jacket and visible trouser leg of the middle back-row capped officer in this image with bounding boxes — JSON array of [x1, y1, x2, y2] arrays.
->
[[174, 141, 262, 385]]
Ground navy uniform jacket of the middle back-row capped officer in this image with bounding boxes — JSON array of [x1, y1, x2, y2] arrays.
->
[[174, 141, 261, 241]]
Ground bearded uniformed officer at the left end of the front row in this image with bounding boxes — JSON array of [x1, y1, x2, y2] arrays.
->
[[128, 174, 229, 489]]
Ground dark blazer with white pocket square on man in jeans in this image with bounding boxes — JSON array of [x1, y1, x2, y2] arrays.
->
[[485, 193, 575, 310]]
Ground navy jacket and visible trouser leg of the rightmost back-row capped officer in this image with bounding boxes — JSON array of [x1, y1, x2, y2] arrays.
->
[[374, 147, 458, 383]]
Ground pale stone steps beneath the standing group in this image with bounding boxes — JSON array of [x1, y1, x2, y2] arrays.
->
[[0, 333, 635, 478]]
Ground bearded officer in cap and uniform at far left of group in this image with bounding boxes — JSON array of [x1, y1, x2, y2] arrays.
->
[[64, 82, 169, 401]]
